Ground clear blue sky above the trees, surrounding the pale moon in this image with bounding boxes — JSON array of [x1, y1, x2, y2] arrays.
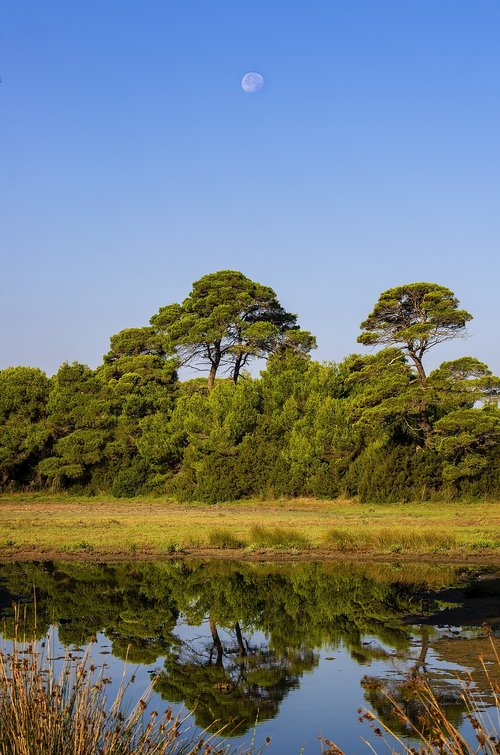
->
[[0, 0, 500, 374]]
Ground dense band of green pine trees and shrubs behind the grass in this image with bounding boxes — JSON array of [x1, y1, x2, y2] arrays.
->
[[0, 270, 500, 503]]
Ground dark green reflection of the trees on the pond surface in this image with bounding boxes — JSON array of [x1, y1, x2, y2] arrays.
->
[[0, 561, 494, 733]]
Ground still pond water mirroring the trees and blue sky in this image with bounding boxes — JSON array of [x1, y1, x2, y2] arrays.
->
[[0, 560, 500, 755]]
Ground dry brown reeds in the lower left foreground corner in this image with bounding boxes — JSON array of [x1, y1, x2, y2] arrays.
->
[[0, 620, 266, 755]]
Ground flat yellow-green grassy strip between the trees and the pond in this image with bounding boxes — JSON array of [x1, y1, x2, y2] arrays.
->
[[0, 495, 500, 560]]
